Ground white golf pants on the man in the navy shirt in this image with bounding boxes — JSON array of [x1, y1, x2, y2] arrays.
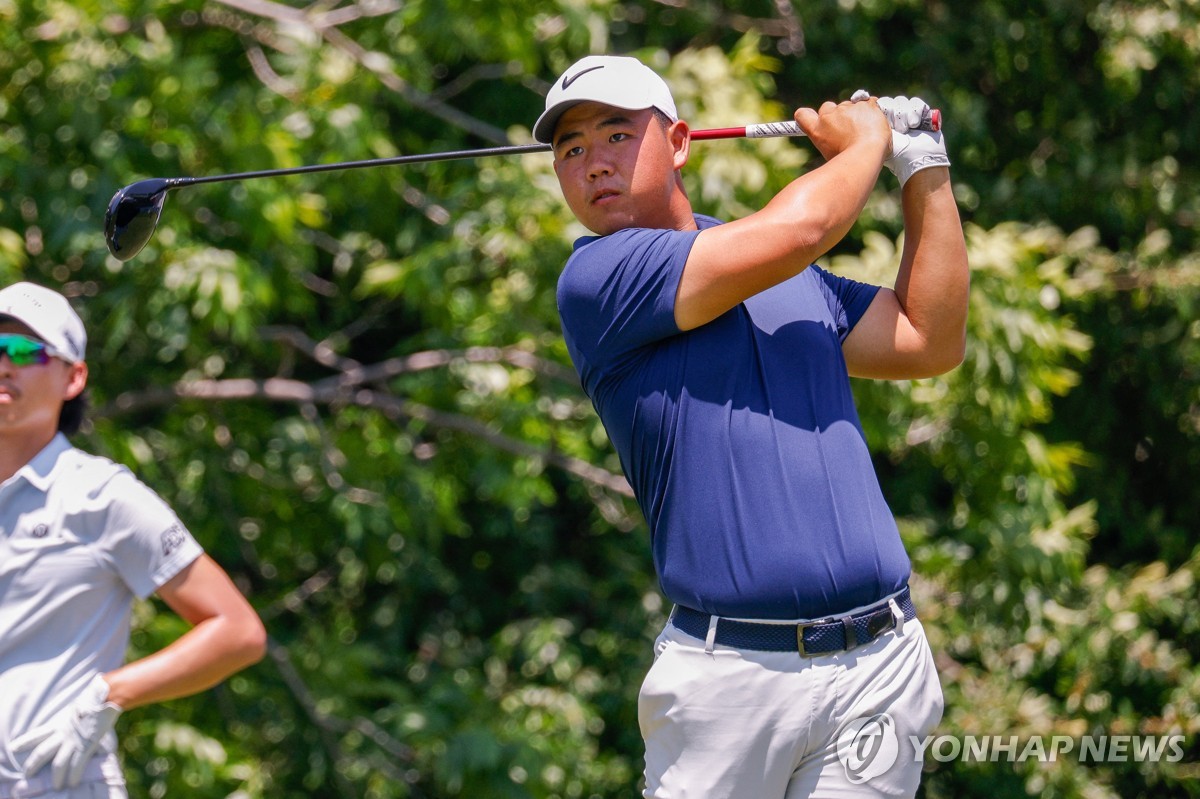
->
[[637, 604, 942, 799]]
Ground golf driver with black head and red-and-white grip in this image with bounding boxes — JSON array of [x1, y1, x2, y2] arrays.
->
[[104, 109, 942, 260]]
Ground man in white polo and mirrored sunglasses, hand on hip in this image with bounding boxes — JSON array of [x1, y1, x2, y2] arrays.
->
[[0, 283, 265, 799]]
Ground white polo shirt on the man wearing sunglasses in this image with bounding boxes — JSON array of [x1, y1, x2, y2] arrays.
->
[[0, 433, 203, 786]]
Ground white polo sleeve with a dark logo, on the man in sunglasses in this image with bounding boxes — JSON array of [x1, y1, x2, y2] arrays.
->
[[97, 468, 203, 599]]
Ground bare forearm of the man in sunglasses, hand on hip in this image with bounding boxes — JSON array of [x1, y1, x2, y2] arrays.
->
[[103, 614, 265, 710]]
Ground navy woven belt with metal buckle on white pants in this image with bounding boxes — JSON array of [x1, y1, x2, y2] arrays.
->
[[671, 585, 917, 655]]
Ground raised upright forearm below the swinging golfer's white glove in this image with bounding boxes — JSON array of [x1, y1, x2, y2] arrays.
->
[[895, 168, 970, 368]]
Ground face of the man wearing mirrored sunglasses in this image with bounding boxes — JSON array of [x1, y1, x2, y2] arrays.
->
[[0, 319, 88, 435]]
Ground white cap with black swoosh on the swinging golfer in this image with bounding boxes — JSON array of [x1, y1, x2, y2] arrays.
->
[[533, 55, 679, 144]]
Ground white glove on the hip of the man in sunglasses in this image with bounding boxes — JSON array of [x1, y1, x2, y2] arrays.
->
[[12, 674, 121, 791]]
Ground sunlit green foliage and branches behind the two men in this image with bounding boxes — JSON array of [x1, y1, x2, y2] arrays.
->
[[0, 0, 1200, 799]]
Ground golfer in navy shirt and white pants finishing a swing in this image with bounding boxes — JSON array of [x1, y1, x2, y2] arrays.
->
[[534, 56, 968, 799]]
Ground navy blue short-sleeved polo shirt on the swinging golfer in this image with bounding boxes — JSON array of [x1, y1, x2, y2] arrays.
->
[[558, 216, 910, 619]]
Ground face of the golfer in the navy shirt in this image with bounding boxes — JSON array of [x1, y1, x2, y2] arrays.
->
[[553, 102, 691, 235]]
